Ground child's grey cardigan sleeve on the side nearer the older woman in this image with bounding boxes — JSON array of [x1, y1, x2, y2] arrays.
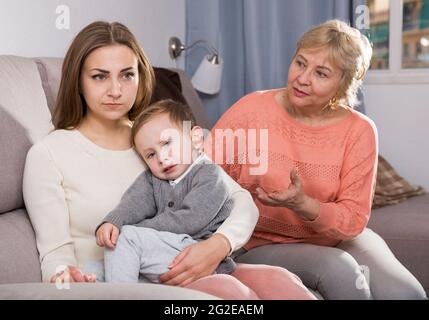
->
[[139, 165, 229, 236]]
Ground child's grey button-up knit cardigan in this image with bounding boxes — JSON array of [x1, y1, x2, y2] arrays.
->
[[103, 159, 235, 273]]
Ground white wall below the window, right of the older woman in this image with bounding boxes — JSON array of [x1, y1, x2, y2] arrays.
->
[[365, 84, 429, 190]]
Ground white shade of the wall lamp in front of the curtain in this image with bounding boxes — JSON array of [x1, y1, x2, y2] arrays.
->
[[191, 55, 223, 94]]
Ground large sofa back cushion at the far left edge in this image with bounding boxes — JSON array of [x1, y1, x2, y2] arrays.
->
[[0, 56, 52, 214]]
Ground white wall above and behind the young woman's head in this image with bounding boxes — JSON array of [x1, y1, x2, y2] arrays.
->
[[0, 0, 186, 68]]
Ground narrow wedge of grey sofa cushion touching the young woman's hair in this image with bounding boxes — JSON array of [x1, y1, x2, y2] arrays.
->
[[34, 58, 63, 113]]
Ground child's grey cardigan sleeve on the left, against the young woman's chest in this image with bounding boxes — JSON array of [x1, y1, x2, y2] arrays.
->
[[97, 170, 156, 228]]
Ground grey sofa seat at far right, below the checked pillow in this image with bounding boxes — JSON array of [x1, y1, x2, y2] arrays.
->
[[368, 194, 429, 292]]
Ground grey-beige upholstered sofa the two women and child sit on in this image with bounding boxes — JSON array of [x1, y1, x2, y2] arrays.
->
[[0, 56, 429, 300]]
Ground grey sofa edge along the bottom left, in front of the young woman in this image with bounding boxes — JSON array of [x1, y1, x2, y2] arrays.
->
[[0, 283, 219, 300]]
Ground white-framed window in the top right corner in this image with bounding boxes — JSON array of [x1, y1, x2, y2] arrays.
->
[[366, 0, 429, 83]]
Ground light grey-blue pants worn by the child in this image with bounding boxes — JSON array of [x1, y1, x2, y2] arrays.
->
[[104, 226, 197, 283]]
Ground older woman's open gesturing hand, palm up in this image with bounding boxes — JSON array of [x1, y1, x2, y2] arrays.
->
[[256, 168, 320, 220]]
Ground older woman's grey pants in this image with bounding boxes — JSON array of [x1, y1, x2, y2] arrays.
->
[[235, 229, 426, 300]]
